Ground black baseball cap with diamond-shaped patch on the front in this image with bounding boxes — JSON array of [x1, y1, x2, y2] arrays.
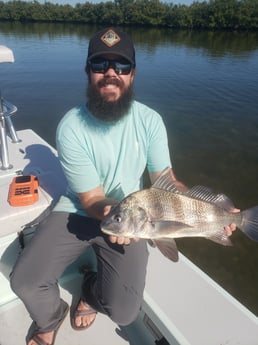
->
[[87, 28, 135, 66]]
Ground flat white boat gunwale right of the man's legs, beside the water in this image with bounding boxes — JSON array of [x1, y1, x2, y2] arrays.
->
[[145, 249, 258, 345]]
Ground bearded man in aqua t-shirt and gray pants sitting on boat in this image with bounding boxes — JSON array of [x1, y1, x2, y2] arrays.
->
[[11, 28, 236, 345]]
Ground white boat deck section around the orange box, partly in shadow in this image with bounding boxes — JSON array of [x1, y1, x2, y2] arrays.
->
[[0, 130, 66, 237]]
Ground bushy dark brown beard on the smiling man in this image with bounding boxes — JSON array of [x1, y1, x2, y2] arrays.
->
[[87, 78, 134, 122]]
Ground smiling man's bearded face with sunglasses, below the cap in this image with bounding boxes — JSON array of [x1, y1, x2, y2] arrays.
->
[[87, 55, 135, 121]]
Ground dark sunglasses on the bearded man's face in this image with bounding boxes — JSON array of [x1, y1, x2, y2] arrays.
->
[[88, 59, 134, 75]]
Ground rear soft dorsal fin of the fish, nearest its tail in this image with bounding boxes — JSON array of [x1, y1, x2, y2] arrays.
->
[[185, 186, 235, 211]]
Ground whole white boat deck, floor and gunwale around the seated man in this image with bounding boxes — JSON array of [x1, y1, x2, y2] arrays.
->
[[0, 130, 258, 345]]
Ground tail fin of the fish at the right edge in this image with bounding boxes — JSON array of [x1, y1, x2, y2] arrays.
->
[[240, 206, 258, 242]]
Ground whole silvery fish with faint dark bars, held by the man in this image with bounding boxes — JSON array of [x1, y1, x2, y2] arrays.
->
[[100, 168, 258, 262]]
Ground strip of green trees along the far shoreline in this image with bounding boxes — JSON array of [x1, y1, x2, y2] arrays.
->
[[0, 0, 258, 30]]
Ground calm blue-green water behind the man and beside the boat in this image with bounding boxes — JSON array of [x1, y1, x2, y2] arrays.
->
[[0, 23, 258, 315]]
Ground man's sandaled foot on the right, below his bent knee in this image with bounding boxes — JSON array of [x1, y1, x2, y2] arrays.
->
[[71, 300, 97, 331]]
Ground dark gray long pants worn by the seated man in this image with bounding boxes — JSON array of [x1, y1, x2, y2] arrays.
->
[[11, 212, 148, 332]]
